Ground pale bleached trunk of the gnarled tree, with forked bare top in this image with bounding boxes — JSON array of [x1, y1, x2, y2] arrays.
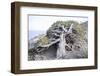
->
[[57, 24, 73, 59]]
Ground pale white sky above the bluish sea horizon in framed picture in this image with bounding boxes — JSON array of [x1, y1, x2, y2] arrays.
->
[[29, 16, 88, 31]]
